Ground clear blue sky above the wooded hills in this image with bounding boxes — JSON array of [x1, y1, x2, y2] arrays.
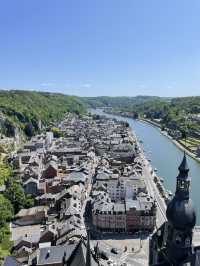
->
[[0, 0, 200, 97]]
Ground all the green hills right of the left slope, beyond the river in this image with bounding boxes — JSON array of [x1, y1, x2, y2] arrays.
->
[[82, 96, 200, 138]]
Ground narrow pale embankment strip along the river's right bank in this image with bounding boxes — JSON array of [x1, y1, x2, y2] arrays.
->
[[139, 118, 200, 163]]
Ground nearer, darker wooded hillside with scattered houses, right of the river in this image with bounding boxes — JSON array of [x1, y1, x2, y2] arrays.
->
[[129, 97, 200, 131]]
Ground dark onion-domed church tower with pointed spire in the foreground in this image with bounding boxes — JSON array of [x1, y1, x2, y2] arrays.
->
[[165, 153, 196, 265]]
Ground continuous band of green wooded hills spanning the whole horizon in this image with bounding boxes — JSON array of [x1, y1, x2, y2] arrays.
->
[[0, 90, 200, 137]]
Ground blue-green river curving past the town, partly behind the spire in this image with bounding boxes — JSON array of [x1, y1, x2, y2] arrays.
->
[[91, 109, 200, 225]]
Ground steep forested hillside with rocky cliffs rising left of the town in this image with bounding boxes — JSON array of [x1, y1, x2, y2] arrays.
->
[[0, 91, 85, 136]]
